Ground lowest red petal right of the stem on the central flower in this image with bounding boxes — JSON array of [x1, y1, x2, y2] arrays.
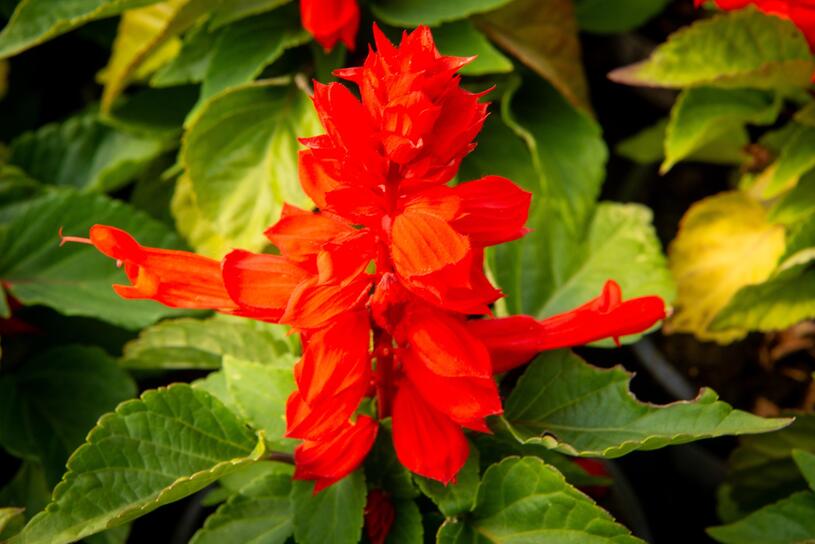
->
[[393, 380, 470, 484]]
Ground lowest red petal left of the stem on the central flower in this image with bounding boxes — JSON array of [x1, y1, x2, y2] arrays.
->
[[294, 416, 379, 493]]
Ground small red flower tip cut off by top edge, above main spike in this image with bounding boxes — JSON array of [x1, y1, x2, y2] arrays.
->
[[300, 0, 359, 51]]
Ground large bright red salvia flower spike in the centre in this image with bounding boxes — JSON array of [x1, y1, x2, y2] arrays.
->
[[60, 27, 665, 490]]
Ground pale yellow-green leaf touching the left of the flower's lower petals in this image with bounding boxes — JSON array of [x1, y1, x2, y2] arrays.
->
[[224, 355, 296, 451]]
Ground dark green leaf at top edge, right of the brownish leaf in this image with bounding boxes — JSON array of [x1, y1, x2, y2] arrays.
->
[[575, 0, 670, 34]]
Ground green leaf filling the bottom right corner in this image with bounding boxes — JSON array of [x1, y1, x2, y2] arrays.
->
[[707, 491, 815, 544]]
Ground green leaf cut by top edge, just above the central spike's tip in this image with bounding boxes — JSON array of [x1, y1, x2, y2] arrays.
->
[[371, 0, 510, 27]]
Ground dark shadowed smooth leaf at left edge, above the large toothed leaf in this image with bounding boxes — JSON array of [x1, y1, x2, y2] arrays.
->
[[0, 346, 136, 485]]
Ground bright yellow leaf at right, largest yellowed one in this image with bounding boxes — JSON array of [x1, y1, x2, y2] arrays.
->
[[665, 192, 784, 343]]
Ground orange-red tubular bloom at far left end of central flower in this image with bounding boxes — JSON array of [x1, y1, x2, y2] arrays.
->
[[90, 225, 236, 312]]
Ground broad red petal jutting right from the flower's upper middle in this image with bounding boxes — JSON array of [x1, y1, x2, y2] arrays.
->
[[453, 176, 532, 246]]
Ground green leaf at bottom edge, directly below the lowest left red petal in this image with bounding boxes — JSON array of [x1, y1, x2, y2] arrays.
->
[[290, 470, 367, 544]]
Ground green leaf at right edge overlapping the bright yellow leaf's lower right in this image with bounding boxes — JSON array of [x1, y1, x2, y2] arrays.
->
[[710, 266, 815, 331]]
